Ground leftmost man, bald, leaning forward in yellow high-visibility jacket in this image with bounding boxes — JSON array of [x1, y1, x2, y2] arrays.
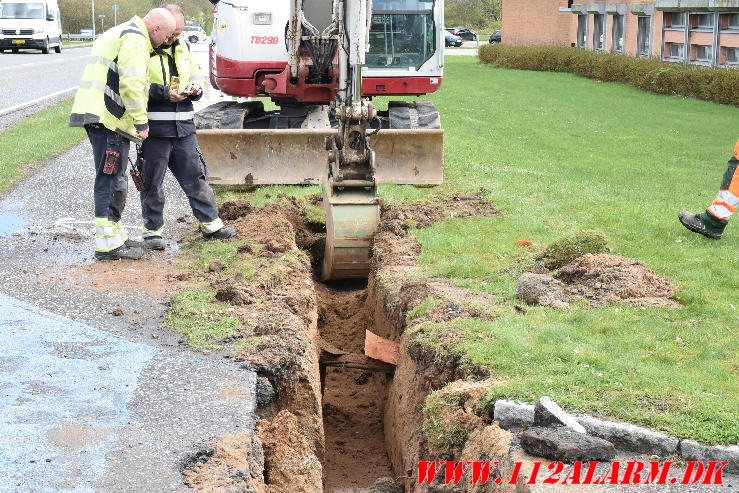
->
[[69, 8, 176, 260]]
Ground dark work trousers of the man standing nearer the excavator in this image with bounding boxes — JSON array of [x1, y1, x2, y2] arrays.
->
[[141, 133, 218, 236]]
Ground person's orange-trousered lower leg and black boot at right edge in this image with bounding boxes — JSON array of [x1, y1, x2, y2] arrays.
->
[[678, 142, 739, 240]]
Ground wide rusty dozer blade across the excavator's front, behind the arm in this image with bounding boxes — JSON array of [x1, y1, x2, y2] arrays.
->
[[197, 129, 444, 185]]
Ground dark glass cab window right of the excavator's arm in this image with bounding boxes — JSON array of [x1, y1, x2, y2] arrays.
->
[[365, 0, 436, 70]]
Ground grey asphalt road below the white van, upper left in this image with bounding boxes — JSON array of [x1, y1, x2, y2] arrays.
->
[[0, 47, 92, 113]]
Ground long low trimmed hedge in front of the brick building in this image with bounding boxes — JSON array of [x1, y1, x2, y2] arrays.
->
[[479, 44, 739, 106]]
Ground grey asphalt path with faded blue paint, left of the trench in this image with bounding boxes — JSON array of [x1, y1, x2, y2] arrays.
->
[[0, 138, 255, 492]]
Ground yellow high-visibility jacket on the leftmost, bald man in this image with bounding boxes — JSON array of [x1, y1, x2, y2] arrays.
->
[[69, 16, 152, 142]]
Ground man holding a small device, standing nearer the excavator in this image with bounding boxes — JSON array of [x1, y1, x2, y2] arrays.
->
[[141, 4, 236, 250]]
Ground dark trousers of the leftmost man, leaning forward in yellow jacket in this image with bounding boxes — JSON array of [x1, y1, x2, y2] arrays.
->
[[85, 125, 131, 222]]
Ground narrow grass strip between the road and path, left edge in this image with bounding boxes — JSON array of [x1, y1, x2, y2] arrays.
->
[[0, 99, 85, 194]]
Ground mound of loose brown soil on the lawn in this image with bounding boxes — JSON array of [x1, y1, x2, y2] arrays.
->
[[557, 254, 680, 308]]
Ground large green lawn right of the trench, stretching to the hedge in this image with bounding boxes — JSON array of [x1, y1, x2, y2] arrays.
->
[[204, 57, 739, 444]]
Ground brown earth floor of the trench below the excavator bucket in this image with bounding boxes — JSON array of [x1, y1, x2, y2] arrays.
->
[[315, 280, 394, 493]]
